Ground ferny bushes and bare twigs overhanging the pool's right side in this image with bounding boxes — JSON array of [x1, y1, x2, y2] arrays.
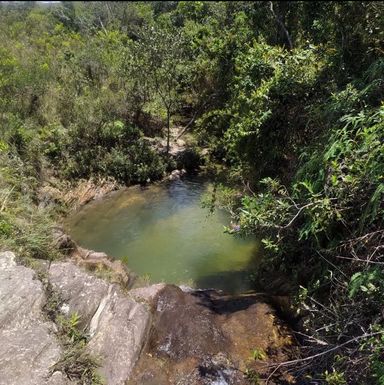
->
[[208, 77, 384, 385]]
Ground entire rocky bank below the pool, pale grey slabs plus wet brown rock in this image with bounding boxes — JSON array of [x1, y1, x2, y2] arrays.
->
[[0, 248, 291, 385]]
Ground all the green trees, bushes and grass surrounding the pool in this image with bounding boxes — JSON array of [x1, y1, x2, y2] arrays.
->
[[0, 1, 384, 385]]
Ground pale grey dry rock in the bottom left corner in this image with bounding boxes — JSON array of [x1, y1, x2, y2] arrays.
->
[[0, 252, 70, 385]]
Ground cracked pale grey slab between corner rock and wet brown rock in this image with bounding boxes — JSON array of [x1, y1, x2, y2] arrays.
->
[[49, 262, 151, 385]]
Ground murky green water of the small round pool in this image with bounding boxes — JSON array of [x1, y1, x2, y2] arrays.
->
[[67, 177, 259, 292]]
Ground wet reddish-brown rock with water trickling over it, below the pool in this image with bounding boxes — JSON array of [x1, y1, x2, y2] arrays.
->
[[128, 285, 291, 385]]
